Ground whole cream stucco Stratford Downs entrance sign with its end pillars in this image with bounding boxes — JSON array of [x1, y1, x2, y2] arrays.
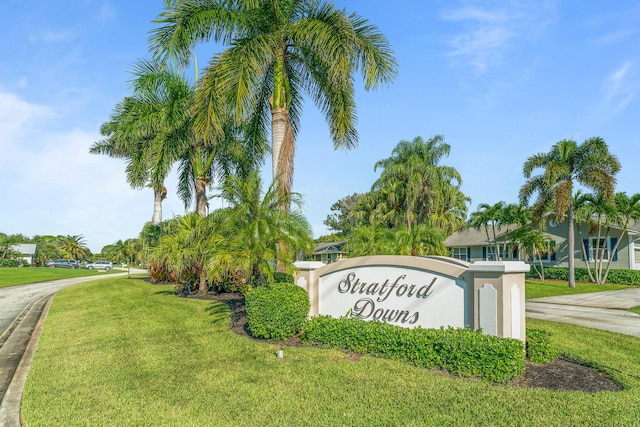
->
[[296, 256, 529, 339]]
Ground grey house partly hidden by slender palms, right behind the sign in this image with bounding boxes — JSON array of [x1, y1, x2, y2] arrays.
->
[[444, 220, 640, 270]]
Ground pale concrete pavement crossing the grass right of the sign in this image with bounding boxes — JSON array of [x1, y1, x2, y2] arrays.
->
[[525, 288, 640, 337]]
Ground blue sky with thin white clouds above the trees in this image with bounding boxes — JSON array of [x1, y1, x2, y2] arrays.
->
[[0, 0, 640, 252]]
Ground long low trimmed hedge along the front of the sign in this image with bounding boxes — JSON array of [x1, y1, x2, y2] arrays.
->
[[301, 316, 525, 382]]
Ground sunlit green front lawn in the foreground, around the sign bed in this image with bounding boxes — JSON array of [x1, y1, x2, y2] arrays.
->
[[22, 278, 640, 426]]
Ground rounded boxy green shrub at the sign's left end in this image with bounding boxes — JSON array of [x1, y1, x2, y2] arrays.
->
[[245, 283, 310, 340]]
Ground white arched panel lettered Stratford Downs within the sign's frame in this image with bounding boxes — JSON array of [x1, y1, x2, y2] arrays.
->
[[318, 265, 472, 328]]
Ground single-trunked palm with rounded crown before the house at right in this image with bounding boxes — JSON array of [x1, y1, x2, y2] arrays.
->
[[519, 137, 620, 288]]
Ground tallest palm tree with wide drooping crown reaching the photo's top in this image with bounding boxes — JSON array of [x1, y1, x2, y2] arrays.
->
[[150, 0, 397, 209]]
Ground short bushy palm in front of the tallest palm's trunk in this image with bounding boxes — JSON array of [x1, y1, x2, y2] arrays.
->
[[209, 171, 313, 283]]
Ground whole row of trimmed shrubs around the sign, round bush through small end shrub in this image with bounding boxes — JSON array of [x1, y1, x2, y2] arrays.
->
[[245, 283, 557, 382]]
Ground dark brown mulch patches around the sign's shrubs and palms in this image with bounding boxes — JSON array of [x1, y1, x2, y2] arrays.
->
[[189, 293, 622, 393]]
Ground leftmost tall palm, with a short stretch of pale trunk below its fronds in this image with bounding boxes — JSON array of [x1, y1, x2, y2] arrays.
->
[[89, 60, 192, 224]]
